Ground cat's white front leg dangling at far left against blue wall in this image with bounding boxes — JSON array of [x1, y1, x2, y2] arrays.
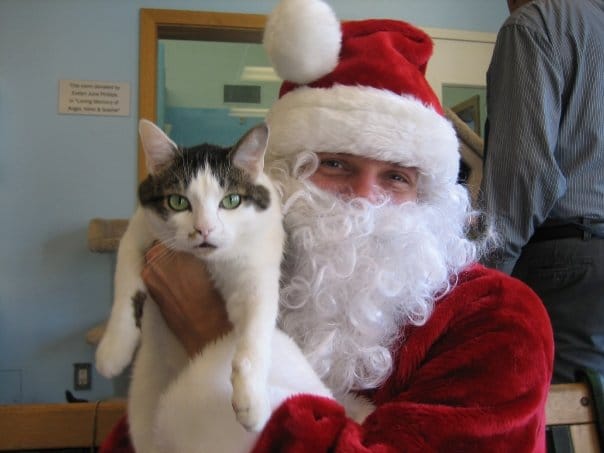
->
[[95, 207, 153, 378]]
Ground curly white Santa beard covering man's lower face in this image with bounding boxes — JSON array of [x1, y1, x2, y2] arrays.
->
[[272, 157, 477, 396]]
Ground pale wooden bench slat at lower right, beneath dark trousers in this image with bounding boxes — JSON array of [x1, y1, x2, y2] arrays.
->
[[545, 383, 595, 425]]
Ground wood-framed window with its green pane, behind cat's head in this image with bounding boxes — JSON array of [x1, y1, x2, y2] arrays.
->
[[138, 9, 270, 181]]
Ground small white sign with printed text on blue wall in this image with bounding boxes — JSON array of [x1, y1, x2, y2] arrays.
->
[[59, 80, 130, 116]]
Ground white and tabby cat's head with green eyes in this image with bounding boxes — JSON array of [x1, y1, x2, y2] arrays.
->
[[138, 120, 271, 255]]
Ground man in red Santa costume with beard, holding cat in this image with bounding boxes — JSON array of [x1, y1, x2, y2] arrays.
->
[[104, 0, 553, 453]]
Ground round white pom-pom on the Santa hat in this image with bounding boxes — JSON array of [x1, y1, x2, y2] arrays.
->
[[264, 0, 342, 84]]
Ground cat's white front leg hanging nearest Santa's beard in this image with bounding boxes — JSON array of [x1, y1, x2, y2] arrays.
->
[[227, 272, 279, 431]]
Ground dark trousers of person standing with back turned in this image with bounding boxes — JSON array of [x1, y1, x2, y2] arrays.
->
[[512, 238, 604, 383]]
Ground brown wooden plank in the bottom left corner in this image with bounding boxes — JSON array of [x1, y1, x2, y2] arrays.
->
[[0, 400, 126, 451]]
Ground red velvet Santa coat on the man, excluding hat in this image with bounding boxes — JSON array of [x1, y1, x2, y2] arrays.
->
[[101, 265, 553, 453]]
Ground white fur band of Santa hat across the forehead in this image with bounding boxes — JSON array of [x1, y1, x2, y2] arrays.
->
[[267, 85, 459, 184]]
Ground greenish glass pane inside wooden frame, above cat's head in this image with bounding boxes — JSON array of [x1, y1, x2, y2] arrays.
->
[[157, 39, 281, 146]]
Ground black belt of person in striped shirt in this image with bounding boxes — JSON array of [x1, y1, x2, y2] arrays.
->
[[529, 217, 604, 242]]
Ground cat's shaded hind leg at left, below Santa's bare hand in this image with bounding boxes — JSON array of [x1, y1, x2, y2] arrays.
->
[[128, 299, 188, 453]]
